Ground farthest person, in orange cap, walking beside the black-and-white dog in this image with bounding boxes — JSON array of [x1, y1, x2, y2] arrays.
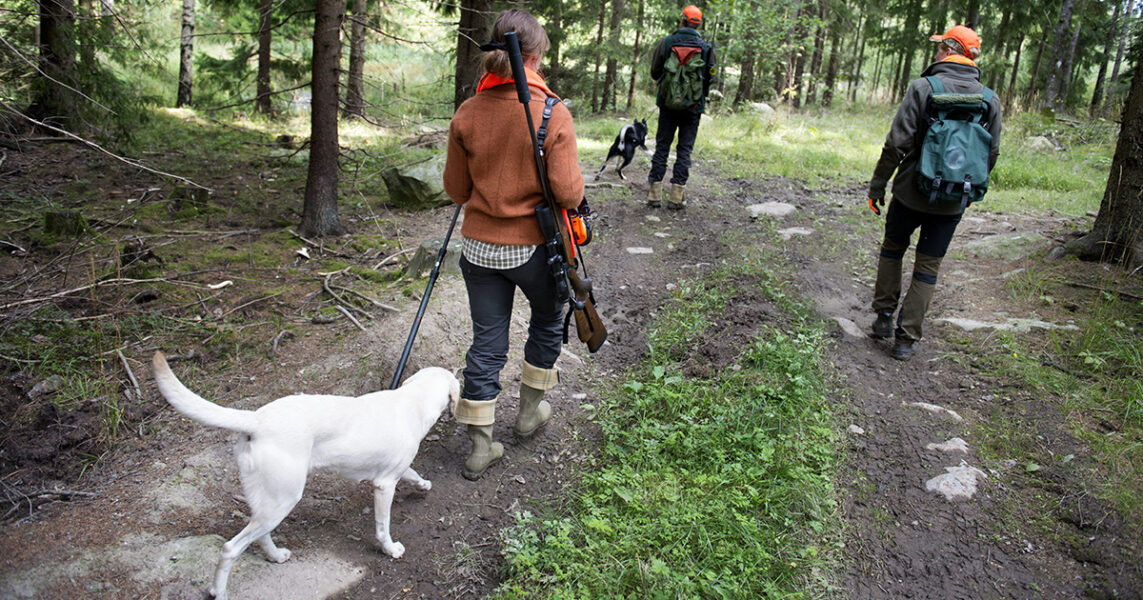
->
[[647, 5, 716, 210]]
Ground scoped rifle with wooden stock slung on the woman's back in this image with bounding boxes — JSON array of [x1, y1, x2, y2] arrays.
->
[[504, 31, 607, 352]]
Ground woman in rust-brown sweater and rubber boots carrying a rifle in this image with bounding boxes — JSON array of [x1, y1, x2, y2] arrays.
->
[[436, 9, 583, 479]]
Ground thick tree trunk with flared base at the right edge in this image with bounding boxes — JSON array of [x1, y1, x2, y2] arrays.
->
[[1053, 49, 1143, 269]]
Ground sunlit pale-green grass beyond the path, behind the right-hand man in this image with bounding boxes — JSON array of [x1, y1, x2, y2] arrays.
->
[[667, 104, 1118, 216]]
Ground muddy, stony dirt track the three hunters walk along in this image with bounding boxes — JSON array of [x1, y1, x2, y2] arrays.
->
[[0, 150, 1143, 600]]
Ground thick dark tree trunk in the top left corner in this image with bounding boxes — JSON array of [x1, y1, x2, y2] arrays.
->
[[29, 0, 75, 121]]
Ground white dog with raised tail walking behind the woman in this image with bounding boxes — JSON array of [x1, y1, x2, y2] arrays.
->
[[152, 352, 461, 600]]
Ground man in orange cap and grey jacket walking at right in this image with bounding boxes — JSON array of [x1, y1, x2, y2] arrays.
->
[[866, 25, 1000, 360]]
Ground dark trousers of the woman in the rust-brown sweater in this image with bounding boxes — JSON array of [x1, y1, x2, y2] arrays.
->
[[461, 246, 563, 401]]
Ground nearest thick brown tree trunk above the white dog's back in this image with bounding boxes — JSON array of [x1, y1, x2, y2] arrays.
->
[[302, 0, 345, 237]]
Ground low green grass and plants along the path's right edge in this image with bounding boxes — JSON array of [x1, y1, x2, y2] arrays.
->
[[964, 264, 1143, 534]]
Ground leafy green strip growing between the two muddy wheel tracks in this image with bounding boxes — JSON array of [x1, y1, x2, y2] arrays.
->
[[496, 251, 839, 599]]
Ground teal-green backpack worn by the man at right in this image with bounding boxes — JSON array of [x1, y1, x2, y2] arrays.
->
[[917, 75, 993, 210]]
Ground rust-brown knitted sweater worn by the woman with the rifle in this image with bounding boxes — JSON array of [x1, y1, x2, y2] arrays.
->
[[436, 83, 583, 246]]
